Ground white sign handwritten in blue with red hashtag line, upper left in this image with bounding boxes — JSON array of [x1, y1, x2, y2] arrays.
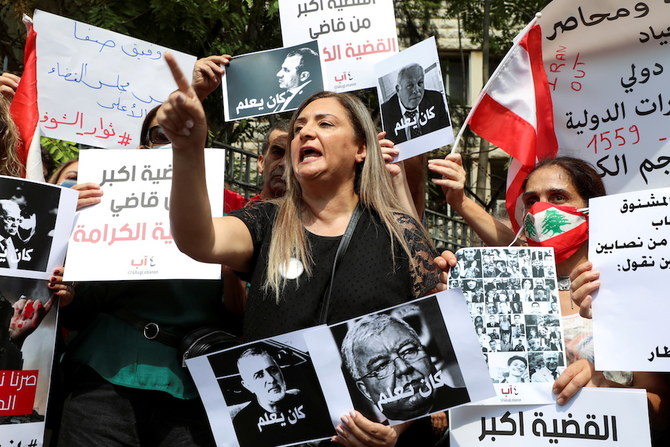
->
[[34, 11, 195, 148]]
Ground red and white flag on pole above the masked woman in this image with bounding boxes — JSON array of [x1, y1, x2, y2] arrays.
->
[[466, 22, 558, 231]]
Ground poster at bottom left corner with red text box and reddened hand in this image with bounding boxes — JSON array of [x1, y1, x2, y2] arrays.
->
[[0, 276, 57, 447]]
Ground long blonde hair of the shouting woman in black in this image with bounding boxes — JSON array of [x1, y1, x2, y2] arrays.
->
[[264, 92, 412, 301]]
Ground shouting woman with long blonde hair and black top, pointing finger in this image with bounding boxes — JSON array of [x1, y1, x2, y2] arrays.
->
[[158, 55, 448, 446]]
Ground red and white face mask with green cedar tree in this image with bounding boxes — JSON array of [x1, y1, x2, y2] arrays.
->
[[523, 202, 589, 263]]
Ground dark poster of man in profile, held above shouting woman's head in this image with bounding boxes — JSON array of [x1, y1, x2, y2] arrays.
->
[[223, 41, 323, 121]]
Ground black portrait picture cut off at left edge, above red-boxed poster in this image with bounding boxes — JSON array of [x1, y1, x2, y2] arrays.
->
[[0, 177, 60, 272]]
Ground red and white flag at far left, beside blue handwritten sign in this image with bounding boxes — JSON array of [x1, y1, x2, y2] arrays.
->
[[9, 15, 44, 181]]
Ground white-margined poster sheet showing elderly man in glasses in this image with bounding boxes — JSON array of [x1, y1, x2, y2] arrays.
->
[[307, 291, 493, 424]]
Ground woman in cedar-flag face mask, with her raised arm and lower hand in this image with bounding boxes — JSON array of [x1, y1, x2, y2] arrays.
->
[[428, 154, 668, 427]]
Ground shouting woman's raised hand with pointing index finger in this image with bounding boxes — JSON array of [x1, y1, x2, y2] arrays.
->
[[156, 53, 207, 151]]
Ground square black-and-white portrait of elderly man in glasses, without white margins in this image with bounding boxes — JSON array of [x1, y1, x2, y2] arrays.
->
[[332, 300, 470, 421]]
